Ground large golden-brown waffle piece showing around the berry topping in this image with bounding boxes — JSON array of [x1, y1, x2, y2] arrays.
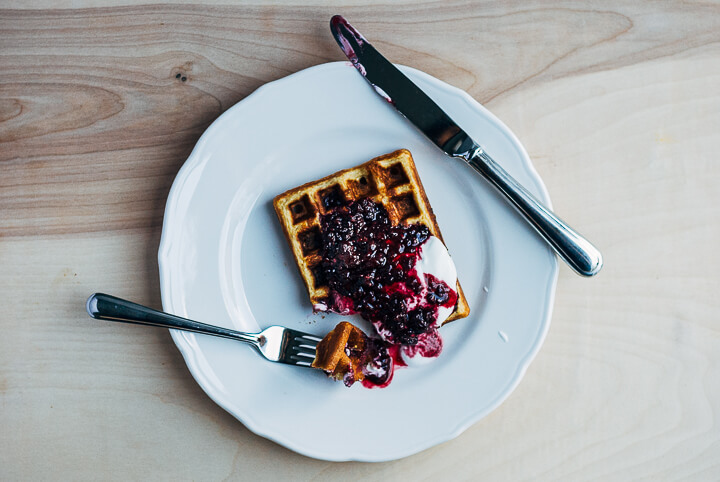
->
[[273, 149, 470, 323]]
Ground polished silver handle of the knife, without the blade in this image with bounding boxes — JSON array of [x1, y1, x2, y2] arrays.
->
[[462, 147, 603, 276]]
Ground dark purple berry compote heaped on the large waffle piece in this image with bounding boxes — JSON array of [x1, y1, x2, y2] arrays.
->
[[319, 198, 457, 386]]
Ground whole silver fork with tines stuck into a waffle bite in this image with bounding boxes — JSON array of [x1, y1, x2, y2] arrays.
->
[[85, 293, 321, 367]]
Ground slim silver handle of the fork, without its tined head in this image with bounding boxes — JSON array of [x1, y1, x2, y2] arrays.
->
[[85, 293, 260, 347]]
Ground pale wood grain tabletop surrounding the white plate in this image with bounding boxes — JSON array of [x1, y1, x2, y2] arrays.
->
[[0, 0, 720, 480]]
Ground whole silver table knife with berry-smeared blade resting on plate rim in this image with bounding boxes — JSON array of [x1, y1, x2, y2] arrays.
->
[[330, 15, 603, 276]]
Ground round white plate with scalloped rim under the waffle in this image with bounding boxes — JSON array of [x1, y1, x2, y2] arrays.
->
[[159, 62, 557, 461]]
